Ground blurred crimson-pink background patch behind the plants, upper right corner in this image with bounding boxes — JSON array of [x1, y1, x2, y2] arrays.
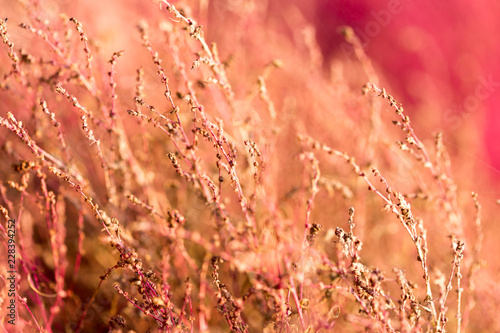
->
[[304, 0, 500, 181]]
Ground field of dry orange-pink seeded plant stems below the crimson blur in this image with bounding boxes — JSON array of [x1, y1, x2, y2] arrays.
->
[[0, 0, 500, 332]]
